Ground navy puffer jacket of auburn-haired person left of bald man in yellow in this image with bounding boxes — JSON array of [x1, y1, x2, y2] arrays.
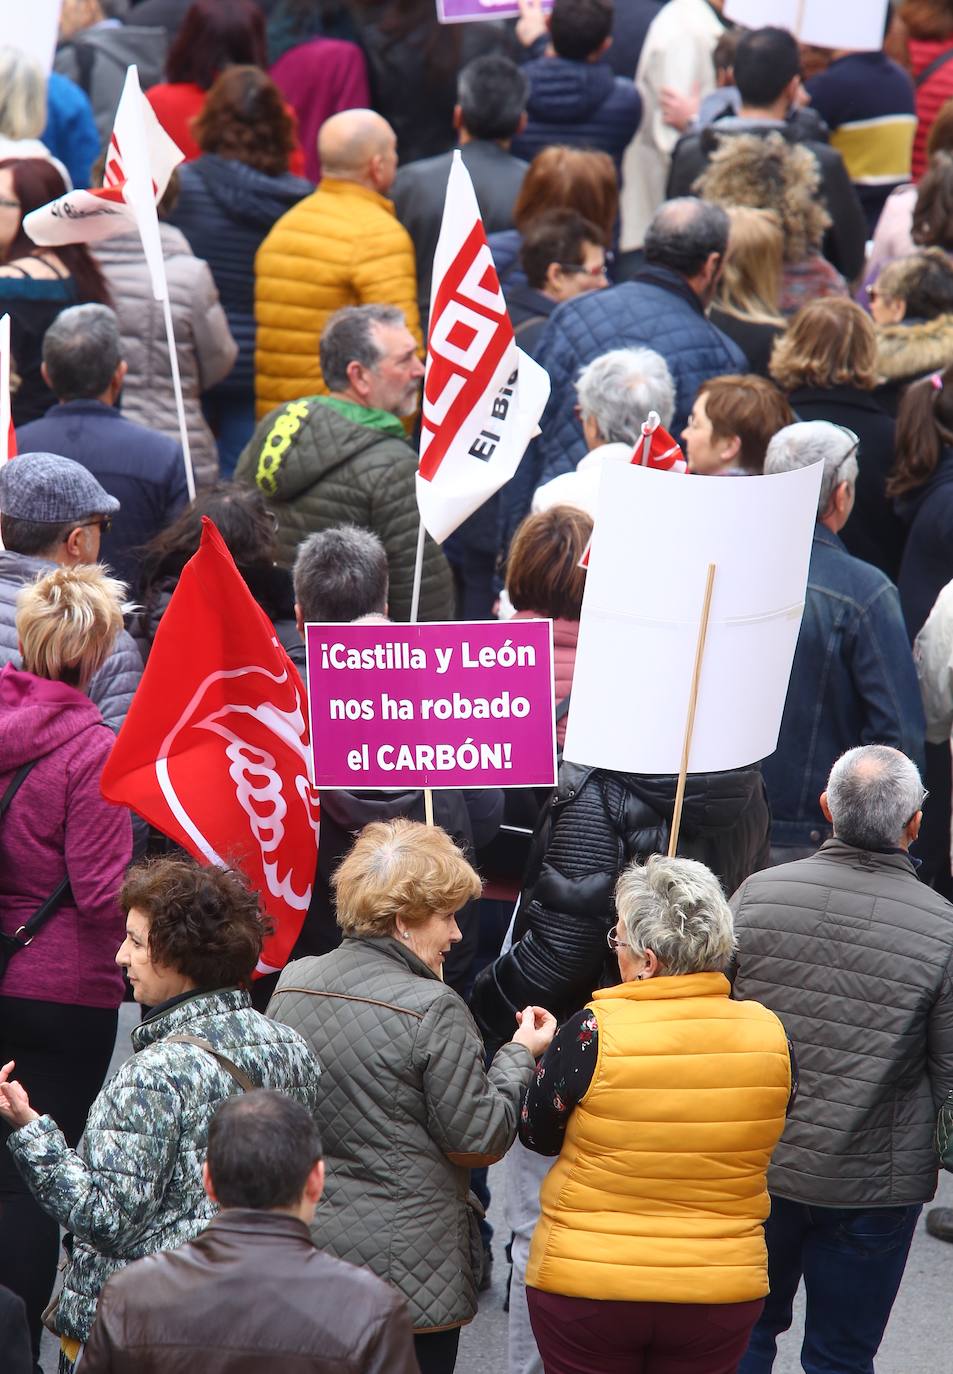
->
[[169, 153, 313, 396]]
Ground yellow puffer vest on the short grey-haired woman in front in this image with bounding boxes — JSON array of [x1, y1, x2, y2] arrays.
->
[[526, 973, 791, 1303]]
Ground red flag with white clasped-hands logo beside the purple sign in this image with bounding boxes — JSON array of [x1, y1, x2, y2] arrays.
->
[[102, 517, 319, 973]]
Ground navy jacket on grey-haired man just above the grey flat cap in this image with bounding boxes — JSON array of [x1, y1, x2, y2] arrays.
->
[[16, 401, 188, 594]]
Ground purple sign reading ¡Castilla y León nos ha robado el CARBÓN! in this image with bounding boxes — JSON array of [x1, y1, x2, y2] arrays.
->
[[306, 620, 556, 789]]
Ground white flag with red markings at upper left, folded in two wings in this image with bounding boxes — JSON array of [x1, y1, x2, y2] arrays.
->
[[23, 66, 184, 301]]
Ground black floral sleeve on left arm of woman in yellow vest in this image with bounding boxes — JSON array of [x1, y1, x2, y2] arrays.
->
[[519, 1007, 599, 1154]]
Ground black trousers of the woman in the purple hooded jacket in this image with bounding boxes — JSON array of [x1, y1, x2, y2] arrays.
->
[[0, 998, 118, 1362]]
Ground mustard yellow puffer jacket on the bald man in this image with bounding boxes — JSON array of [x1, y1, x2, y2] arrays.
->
[[255, 177, 420, 419]]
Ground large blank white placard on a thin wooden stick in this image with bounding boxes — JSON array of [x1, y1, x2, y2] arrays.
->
[[564, 463, 823, 774]]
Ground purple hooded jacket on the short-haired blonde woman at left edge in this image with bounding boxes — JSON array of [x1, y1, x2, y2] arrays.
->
[[0, 664, 132, 1007]]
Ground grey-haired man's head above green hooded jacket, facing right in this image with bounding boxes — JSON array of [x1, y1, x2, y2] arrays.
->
[[320, 305, 423, 416]]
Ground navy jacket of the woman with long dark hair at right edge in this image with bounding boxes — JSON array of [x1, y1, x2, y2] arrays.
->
[[897, 448, 953, 643]]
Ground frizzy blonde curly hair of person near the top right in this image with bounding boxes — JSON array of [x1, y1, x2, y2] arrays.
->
[[692, 133, 831, 262]]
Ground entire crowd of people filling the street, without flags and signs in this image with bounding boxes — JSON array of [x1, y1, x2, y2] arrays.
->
[[0, 0, 953, 1374]]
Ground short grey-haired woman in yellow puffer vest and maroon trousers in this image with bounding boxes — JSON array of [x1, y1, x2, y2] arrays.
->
[[519, 855, 792, 1374]]
